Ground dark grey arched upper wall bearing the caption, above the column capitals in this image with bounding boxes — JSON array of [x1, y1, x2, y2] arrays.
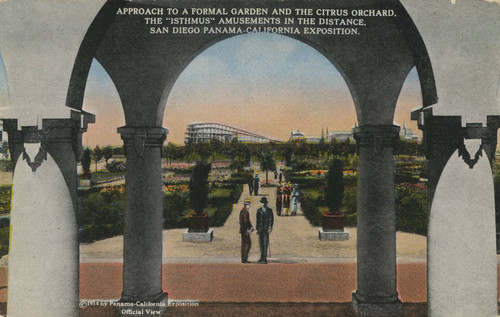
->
[[68, 0, 437, 126]]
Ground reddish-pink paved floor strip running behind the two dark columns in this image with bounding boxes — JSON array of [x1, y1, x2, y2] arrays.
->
[[73, 263, 426, 303]]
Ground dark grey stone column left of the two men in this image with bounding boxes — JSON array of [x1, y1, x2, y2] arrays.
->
[[118, 126, 168, 303]]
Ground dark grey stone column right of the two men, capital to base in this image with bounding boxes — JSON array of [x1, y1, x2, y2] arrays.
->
[[352, 125, 403, 316]]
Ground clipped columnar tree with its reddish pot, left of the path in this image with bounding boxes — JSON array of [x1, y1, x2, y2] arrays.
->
[[188, 160, 212, 232]]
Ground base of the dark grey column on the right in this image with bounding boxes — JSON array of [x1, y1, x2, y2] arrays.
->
[[352, 292, 403, 317]]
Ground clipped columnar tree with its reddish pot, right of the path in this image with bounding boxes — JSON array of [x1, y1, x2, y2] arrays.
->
[[323, 159, 344, 232]]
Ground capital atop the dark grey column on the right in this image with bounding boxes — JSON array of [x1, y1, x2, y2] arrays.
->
[[354, 125, 400, 151]]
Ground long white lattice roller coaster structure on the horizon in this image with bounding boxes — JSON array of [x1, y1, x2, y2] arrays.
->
[[185, 122, 276, 143]]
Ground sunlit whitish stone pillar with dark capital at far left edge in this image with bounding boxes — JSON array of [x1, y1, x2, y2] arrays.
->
[[3, 113, 93, 317]]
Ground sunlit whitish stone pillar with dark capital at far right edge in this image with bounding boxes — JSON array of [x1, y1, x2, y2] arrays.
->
[[413, 109, 500, 317]]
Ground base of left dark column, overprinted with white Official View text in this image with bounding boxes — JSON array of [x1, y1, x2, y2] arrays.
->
[[116, 293, 168, 317]]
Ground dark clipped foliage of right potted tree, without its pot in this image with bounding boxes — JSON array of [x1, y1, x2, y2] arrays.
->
[[325, 159, 344, 215]]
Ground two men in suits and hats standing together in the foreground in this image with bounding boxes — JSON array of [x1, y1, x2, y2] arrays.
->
[[240, 197, 274, 264]]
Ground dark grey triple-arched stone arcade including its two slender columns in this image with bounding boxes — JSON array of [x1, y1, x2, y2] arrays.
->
[[63, 0, 437, 315]]
